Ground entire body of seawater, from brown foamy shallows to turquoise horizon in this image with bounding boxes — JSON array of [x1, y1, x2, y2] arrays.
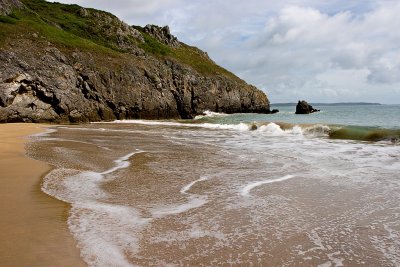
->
[[28, 106, 400, 267]]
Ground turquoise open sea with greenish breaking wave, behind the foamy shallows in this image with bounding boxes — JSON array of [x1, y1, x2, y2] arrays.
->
[[191, 104, 400, 142]]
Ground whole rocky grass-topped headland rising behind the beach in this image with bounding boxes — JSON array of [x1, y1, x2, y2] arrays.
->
[[0, 0, 269, 122]]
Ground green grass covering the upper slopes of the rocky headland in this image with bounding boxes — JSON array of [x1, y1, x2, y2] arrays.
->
[[0, 0, 240, 80]]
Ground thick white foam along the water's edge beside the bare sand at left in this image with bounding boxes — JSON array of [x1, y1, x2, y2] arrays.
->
[[42, 150, 147, 266]]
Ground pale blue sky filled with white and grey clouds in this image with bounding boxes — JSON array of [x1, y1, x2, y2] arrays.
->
[[48, 0, 400, 104]]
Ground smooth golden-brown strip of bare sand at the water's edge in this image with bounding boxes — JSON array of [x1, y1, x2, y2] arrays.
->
[[0, 124, 86, 267]]
